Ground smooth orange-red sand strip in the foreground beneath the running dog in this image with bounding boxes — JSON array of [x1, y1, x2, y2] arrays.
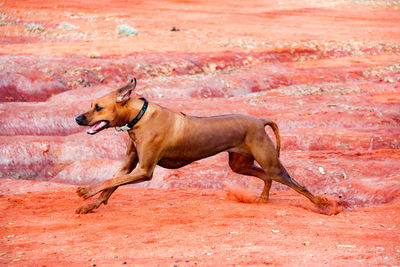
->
[[0, 183, 400, 266]]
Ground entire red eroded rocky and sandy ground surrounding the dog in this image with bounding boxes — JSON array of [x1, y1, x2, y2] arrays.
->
[[0, 0, 400, 266]]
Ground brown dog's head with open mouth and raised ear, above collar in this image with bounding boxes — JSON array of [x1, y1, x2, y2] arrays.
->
[[75, 78, 136, 134]]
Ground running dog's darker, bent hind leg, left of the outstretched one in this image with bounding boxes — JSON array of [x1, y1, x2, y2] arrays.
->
[[229, 152, 272, 202]]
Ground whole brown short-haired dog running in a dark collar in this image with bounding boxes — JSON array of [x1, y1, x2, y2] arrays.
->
[[76, 79, 330, 213]]
